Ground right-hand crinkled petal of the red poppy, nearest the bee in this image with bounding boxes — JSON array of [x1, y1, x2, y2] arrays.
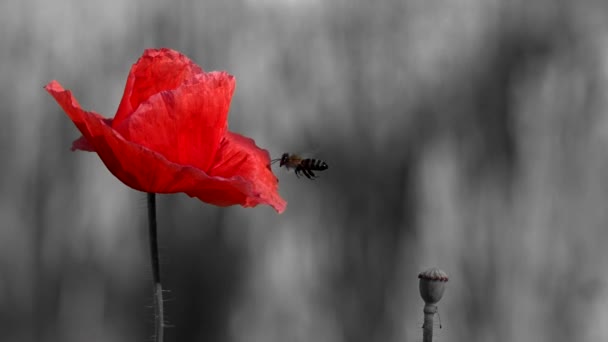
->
[[209, 132, 287, 213]]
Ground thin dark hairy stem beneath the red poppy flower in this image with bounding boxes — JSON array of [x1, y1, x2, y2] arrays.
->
[[148, 193, 165, 342]]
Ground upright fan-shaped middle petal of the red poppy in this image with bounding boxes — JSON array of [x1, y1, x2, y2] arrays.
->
[[114, 72, 235, 171]]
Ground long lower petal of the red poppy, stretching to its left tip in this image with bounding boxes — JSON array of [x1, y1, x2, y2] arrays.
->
[[45, 81, 285, 212]]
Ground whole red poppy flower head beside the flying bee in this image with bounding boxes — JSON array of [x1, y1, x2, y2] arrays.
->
[[45, 49, 286, 213]]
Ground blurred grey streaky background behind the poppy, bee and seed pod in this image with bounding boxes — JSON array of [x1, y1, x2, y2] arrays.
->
[[0, 0, 608, 342]]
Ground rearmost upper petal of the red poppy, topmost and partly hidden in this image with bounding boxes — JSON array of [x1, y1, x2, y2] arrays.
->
[[114, 49, 202, 125]]
